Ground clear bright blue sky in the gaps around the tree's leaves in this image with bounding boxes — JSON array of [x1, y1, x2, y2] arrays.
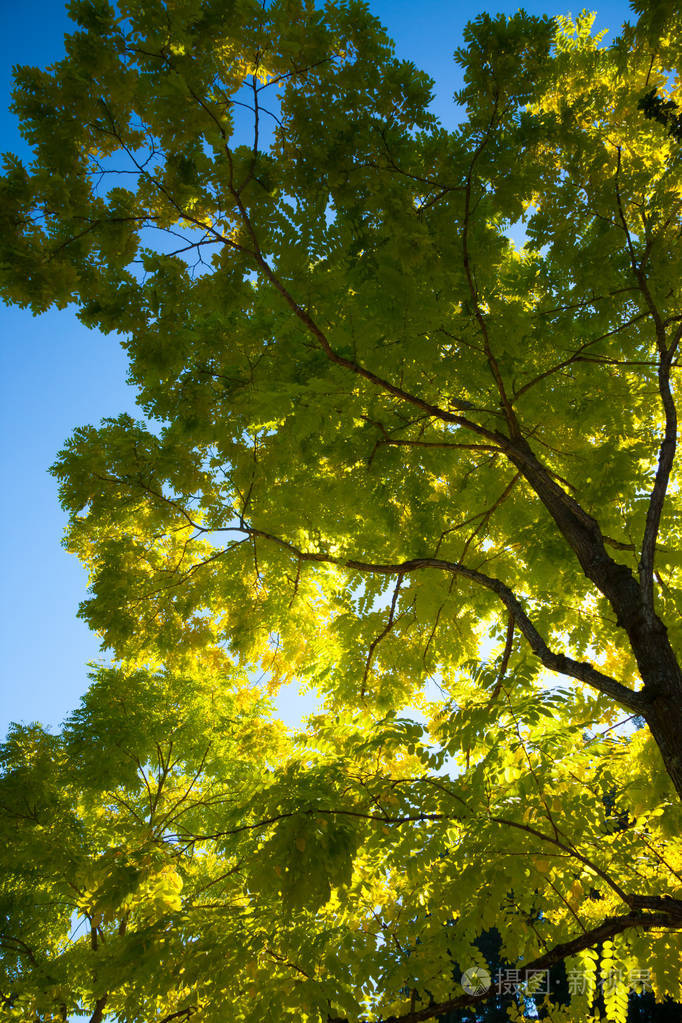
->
[[0, 0, 629, 739]]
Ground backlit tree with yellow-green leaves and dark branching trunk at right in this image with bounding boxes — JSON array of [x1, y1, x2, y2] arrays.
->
[[0, 0, 682, 1023]]
